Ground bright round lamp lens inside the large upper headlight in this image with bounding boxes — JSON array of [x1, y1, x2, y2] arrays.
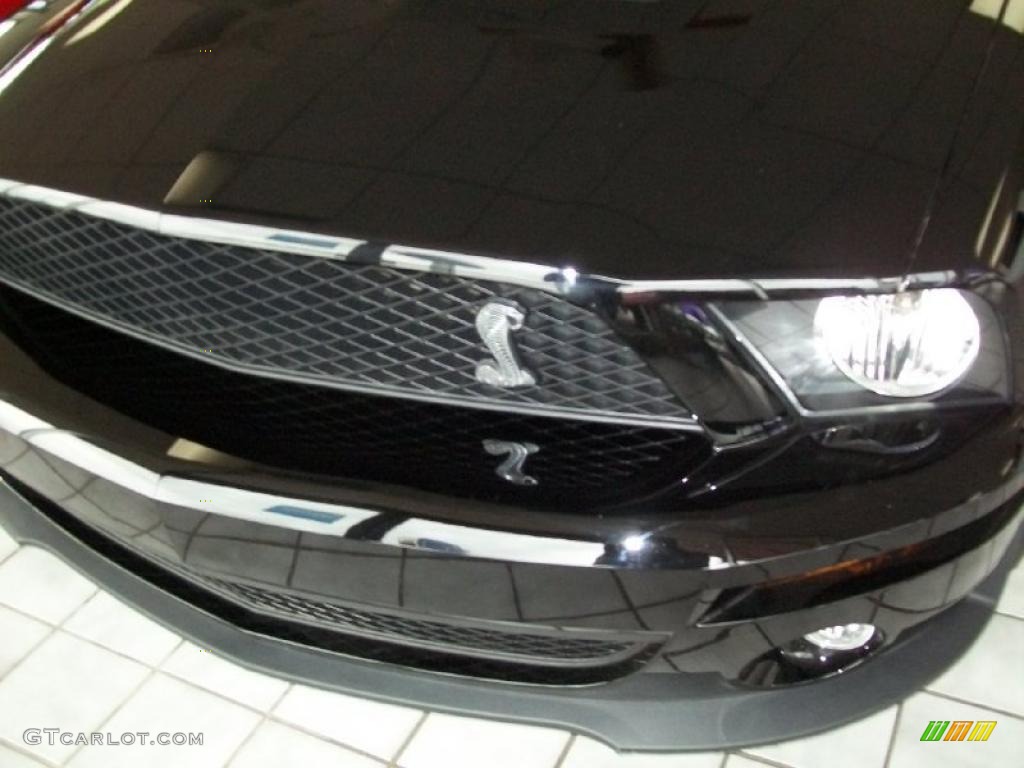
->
[[814, 288, 981, 397]]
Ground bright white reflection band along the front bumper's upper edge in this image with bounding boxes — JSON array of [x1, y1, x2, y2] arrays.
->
[[0, 399, 605, 565]]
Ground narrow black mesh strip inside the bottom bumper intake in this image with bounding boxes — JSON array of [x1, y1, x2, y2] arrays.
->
[[201, 575, 646, 663]]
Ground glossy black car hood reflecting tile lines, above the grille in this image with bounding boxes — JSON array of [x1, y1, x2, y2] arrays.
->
[[0, 0, 1024, 279]]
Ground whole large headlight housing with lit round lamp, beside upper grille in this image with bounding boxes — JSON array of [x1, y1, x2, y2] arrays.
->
[[715, 288, 1011, 412]]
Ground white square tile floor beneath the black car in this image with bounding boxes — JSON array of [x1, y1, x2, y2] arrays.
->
[[0, 529, 1024, 768]]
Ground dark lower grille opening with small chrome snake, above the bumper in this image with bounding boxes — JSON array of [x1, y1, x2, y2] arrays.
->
[[0, 286, 709, 514]]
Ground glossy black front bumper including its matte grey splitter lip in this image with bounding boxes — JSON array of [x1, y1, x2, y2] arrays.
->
[[0, 370, 1021, 751]]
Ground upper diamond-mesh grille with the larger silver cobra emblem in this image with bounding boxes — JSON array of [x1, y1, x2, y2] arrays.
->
[[0, 198, 689, 423]]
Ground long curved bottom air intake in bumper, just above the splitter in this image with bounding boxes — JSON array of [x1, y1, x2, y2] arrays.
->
[[3, 477, 664, 685]]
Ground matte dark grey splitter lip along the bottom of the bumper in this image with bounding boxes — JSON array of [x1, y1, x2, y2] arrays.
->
[[0, 481, 1024, 752]]
